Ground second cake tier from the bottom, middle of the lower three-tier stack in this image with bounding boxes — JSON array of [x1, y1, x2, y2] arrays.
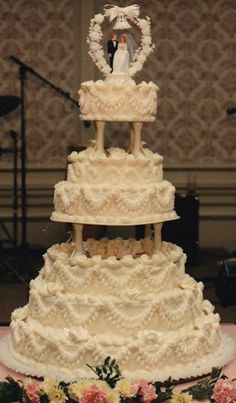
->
[[20, 278, 213, 337]]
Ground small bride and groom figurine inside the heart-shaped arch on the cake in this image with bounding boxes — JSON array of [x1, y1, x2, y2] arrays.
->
[[107, 32, 130, 74]]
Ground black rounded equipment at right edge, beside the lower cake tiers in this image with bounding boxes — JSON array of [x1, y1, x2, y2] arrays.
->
[[215, 258, 236, 306]]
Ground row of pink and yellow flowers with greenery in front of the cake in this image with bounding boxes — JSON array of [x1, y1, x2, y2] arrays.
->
[[0, 357, 236, 403]]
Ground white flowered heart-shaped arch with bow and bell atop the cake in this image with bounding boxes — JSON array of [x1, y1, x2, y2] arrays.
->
[[87, 4, 155, 76]]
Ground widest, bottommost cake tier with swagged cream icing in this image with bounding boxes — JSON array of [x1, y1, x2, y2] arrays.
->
[[11, 312, 222, 380]]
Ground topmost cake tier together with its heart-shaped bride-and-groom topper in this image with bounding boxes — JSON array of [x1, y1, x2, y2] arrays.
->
[[79, 4, 158, 122]]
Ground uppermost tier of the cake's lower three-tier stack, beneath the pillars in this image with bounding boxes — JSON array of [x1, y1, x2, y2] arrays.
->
[[39, 238, 186, 295]]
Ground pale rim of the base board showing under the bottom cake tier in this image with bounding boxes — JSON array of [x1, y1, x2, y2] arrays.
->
[[0, 333, 236, 383]]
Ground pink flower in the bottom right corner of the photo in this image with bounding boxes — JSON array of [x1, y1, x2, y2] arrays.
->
[[212, 379, 236, 403]]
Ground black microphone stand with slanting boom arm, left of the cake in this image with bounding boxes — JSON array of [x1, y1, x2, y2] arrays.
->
[[10, 56, 79, 249]]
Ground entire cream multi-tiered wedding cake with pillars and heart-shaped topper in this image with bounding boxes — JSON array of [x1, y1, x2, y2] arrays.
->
[[1, 6, 234, 381]]
